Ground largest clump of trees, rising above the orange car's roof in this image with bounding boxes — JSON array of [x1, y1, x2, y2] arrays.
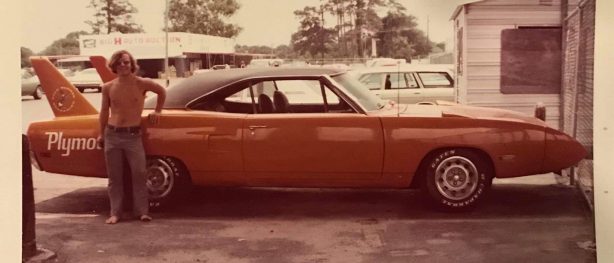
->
[[291, 0, 441, 60]]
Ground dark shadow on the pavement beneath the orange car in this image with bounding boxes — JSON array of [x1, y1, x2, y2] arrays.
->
[[35, 184, 592, 222]]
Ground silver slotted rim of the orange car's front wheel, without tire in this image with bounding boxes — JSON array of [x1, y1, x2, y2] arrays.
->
[[435, 156, 479, 200]]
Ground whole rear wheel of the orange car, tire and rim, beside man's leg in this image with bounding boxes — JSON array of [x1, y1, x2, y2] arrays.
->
[[146, 156, 191, 208]]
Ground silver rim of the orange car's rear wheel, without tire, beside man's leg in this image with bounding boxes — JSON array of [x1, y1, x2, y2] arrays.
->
[[146, 158, 175, 199]]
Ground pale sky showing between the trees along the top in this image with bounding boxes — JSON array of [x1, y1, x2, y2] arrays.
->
[[20, 0, 461, 52]]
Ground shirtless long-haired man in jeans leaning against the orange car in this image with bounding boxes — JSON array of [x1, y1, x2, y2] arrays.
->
[[98, 50, 166, 224]]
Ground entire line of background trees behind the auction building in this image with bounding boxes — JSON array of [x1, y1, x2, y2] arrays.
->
[[21, 0, 442, 67]]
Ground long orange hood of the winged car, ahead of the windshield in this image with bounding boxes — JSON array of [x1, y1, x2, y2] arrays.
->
[[379, 101, 546, 126]]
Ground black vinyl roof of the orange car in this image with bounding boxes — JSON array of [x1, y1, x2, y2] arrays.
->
[[145, 67, 346, 108]]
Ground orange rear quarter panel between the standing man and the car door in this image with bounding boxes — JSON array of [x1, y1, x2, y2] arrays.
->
[[144, 110, 247, 185]]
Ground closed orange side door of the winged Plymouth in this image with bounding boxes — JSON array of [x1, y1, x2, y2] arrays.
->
[[243, 80, 384, 186]]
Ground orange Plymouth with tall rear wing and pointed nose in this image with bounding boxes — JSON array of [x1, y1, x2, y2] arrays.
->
[[28, 58, 586, 210]]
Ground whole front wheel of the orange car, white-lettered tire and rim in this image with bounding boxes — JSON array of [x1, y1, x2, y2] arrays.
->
[[423, 149, 493, 212]]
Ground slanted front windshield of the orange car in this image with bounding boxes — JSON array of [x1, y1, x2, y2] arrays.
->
[[332, 72, 387, 111]]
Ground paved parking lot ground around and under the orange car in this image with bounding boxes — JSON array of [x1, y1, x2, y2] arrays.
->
[[22, 92, 596, 262]]
